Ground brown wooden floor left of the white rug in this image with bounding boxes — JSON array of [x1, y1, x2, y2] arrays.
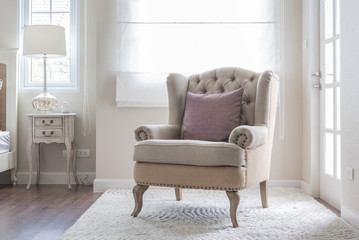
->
[[0, 185, 101, 240]]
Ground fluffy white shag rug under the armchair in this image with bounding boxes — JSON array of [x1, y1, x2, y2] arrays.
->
[[61, 187, 359, 240]]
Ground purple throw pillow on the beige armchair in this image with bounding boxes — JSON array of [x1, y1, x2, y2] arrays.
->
[[183, 88, 244, 142]]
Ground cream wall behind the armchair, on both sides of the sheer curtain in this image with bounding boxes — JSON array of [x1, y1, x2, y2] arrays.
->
[[96, 0, 302, 187]]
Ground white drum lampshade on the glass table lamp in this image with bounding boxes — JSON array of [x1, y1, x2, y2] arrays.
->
[[23, 25, 66, 58]]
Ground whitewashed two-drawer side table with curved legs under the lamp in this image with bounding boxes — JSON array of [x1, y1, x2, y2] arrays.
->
[[26, 113, 79, 189]]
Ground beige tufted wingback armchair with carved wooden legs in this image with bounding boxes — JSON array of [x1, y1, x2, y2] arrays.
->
[[132, 67, 279, 227]]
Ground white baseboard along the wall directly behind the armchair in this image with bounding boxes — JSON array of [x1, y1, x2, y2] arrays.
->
[[94, 178, 302, 192]]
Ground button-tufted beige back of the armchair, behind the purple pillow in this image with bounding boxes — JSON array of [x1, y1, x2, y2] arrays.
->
[[167, 67, 273, 138]]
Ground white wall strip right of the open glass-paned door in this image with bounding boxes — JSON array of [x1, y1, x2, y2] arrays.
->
[[341, 0, 359, 228]]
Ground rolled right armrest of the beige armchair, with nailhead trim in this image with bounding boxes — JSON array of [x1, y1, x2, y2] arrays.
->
[[229, 125, 268, 148]]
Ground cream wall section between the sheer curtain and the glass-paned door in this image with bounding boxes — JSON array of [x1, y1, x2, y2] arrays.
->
[[271, 0, 302, 180]]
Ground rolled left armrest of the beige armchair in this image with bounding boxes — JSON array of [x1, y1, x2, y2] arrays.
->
[[135, 124, 181, 141]]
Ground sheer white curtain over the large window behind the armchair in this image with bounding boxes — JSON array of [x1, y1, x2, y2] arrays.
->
[[116, 0, 282, 107]]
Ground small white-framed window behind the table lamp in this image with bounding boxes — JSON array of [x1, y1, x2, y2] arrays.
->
[[20, 0, 79, 92]]
